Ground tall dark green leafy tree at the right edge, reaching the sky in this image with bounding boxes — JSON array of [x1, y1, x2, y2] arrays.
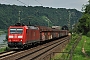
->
[[78, 0, 90, 35]]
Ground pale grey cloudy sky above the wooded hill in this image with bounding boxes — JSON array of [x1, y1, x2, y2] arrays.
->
[[0, 0, 88, 11]]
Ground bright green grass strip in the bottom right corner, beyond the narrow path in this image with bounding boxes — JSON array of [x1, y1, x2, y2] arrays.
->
[[73, 36, 90, 60]]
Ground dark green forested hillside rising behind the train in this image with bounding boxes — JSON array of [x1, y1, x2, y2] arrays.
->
[[0, 4, 82, 29]]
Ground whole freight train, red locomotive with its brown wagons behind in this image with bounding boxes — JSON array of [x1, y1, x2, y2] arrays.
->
[[8, 23, 68, 48]]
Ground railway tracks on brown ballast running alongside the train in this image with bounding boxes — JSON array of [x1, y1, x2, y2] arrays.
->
[[0, 37, 69, 60]]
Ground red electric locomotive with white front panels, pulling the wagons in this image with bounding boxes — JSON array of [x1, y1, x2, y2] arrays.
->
[[8, 23, 40, 48]]
